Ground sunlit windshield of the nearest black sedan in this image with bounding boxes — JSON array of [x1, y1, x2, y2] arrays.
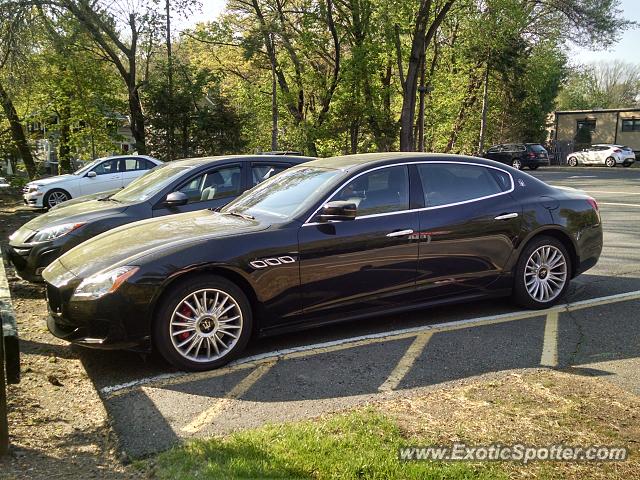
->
[[221, 166, 343, 220]]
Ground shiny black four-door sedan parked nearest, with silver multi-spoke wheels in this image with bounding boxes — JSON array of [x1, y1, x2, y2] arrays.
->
[[43, 153, 602, 370]]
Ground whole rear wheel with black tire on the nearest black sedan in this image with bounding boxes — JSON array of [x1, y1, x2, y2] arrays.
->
[[513, 236, 572, 309]]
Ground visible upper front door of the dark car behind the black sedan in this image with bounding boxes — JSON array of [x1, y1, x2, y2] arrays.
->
[[153, 163, 242, 217]]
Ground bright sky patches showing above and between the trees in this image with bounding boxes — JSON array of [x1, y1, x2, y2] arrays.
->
[[178, 0, 640, 64]]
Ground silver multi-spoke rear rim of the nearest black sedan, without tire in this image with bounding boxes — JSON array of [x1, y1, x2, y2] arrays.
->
[[524, 245, 567, 303]]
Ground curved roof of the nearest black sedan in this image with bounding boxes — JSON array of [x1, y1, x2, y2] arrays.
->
[[298, 152, 504, 171]]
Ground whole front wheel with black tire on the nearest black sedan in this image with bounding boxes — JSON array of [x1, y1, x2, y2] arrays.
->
[[151, 275, 253, 371]]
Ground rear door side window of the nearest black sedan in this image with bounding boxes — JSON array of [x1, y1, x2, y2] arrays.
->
[[418, 163, 504, 207]]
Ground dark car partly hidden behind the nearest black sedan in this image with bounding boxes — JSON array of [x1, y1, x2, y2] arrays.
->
[[7, 155, 312, 281]]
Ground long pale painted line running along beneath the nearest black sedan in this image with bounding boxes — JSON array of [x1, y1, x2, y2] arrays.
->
[[100, 290, 640, 398]]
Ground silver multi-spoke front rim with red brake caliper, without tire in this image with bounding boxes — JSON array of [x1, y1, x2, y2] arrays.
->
[[169, 288, 243, 362]]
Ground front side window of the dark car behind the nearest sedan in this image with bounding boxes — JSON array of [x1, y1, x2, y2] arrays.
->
[[178, 165, 241, 203]]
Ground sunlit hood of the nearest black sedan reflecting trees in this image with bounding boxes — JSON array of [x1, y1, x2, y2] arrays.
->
[[43, 210, 270, 283]]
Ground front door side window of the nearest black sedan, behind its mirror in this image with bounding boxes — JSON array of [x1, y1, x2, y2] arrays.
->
[[333, 165, 409, 217]]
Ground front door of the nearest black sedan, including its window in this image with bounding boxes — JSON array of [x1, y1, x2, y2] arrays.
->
[[299, 165, 418, 318]]
